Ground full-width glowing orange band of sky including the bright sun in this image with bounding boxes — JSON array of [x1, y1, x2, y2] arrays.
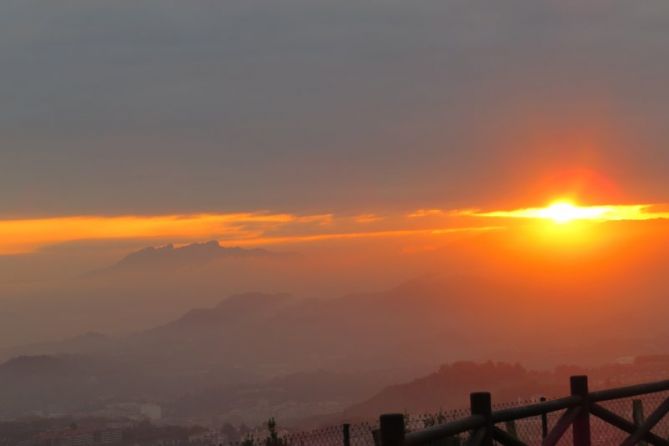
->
[[0, 200, 669, 255]]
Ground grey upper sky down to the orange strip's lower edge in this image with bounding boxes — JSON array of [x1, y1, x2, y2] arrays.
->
[[0, 0, 669, 270]]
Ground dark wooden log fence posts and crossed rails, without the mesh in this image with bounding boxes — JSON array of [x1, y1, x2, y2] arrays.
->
[[374, 376, 669, 446]]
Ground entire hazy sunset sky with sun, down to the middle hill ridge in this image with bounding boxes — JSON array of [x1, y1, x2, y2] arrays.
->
[[5, 0, 669, 356]]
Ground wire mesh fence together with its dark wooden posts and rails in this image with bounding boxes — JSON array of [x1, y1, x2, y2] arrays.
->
[[231, 376, 669, 446]]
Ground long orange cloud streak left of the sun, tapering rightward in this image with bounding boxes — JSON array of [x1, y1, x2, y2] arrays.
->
[[0, 208, 500, 255]]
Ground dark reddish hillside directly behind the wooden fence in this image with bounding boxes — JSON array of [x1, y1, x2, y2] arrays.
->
[[335, 355, 669, 420]]
